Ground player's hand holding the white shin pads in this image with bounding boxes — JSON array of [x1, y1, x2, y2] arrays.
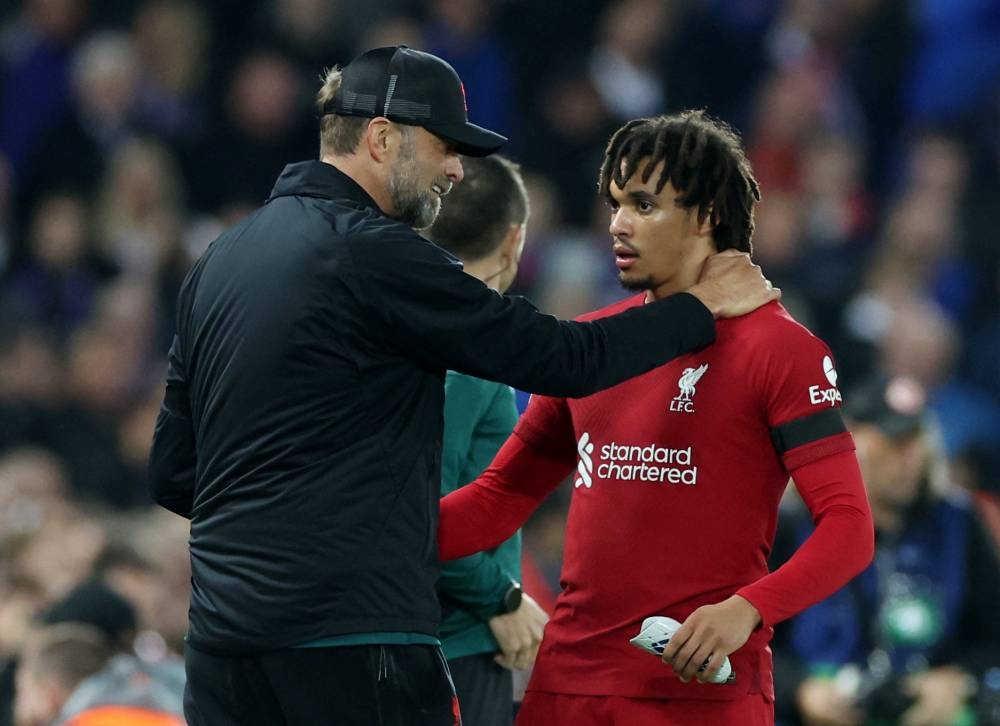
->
[[662, 595, 760, 683]]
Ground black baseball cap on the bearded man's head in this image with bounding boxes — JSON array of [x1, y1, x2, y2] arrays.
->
[[323, 45, 507, 156]]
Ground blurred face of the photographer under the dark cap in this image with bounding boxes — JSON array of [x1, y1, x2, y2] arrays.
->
[[852, 423, 931, 510]]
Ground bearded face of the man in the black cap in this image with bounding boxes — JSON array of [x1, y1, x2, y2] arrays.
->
[[389, 126, 462, 229]]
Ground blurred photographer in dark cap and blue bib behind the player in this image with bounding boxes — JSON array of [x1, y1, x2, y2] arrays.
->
[[772, 377, 1000, 726]]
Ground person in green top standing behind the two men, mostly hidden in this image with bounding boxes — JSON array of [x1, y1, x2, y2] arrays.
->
[[426, 155, 548, 726]]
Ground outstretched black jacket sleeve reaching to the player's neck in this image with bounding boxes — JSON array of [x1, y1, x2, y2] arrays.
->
[[352, 230, 715, 397]]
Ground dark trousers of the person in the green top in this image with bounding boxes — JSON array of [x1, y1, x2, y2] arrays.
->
[[448, 653, 514, 726]]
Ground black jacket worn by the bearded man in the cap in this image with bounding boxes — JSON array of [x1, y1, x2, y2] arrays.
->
[[149, 161, 715, 654]]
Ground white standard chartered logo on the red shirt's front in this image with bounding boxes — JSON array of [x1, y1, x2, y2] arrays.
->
[[573, 431, 698, 489]]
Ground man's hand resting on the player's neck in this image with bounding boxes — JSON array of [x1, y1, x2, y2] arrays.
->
[[688, 250, 781, 318]]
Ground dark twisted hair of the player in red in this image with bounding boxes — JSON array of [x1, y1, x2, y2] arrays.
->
[[598, 110, 760, 252]]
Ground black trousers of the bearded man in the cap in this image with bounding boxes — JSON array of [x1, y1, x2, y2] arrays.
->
[[184, 645, 458, 726]]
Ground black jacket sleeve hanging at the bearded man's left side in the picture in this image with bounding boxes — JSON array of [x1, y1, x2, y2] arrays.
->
[[149, 336, 197, 519]]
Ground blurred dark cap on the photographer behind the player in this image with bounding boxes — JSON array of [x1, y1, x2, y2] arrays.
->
[[845, 376, 928, 438]]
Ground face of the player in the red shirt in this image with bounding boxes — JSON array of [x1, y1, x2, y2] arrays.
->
[[609, 160, 716, 298]]
